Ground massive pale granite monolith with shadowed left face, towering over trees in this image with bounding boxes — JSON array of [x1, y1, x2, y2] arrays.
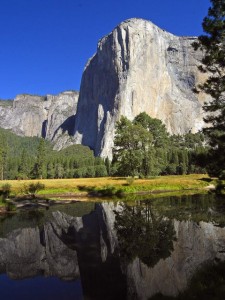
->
[[75, 19, 211, 157]]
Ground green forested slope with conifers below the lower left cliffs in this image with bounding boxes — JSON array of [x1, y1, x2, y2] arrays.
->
[[0, 128, 108, 180]]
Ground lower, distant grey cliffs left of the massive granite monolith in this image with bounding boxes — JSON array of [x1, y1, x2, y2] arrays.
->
[[0, 91, 79, 148]]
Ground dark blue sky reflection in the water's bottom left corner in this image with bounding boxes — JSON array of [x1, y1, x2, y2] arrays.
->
[[0, 275, 83, 300]]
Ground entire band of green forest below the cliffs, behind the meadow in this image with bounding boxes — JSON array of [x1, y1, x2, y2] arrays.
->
[[0, 113, 207, 179]]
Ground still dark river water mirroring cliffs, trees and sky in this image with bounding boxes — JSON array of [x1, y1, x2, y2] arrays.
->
[[0, 195, 225, 300]]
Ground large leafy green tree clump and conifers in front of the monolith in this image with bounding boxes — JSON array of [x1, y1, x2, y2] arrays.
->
[[110, 113, 207, 178]]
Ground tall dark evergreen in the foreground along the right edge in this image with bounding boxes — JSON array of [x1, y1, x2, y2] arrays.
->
[[193, 0, 225, 176]]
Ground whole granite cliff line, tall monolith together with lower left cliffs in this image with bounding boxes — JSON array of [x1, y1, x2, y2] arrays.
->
[[0, 18, 210, 158]]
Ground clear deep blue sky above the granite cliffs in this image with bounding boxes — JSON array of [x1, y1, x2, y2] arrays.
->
[[0, 0, 210, 99]]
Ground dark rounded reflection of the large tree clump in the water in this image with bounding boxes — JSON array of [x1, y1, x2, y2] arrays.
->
[[115, 202, 176, 267]]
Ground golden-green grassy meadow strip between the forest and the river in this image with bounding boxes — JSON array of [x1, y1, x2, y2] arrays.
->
[[0, 174, 212, 196]]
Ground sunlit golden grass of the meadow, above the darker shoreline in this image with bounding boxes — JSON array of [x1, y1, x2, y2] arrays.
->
[[0, 174, 209, 194]]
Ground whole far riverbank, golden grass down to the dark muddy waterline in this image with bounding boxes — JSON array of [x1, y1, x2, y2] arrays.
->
[[0, 174, 214, 212]]
